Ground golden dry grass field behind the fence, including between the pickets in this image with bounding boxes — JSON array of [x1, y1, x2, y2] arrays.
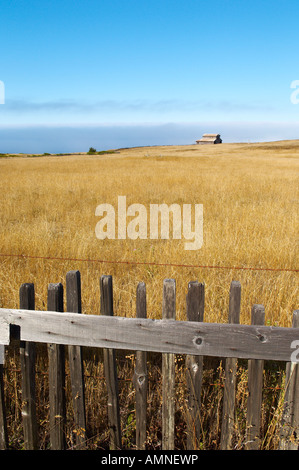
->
[[0, 141, 299, 448]]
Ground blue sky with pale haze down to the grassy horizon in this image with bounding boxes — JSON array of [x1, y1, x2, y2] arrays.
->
[[0, 0, 299, 152]]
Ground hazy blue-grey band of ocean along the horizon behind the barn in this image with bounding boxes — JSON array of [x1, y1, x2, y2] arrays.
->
[[0, 122, 299, 153]]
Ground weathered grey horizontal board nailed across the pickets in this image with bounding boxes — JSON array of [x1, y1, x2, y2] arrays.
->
[[0, 308, 299, 361]]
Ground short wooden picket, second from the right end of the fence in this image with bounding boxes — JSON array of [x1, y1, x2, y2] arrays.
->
[[245, 304, 265, 450]]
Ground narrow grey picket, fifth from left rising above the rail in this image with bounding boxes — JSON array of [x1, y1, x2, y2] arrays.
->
[[133, 282, 147, 450]]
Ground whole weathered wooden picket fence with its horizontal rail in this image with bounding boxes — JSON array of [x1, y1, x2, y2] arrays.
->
[[0, 271, 299, 450]]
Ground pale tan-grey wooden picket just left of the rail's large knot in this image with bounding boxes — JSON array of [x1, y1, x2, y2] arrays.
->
[[162, 279, 176, 450]]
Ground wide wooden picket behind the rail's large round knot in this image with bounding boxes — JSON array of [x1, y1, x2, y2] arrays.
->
[[186, 281, 205, 450]]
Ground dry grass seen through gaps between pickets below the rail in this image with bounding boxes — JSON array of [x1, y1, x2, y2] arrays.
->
[[4, 347, 284, 450]]
